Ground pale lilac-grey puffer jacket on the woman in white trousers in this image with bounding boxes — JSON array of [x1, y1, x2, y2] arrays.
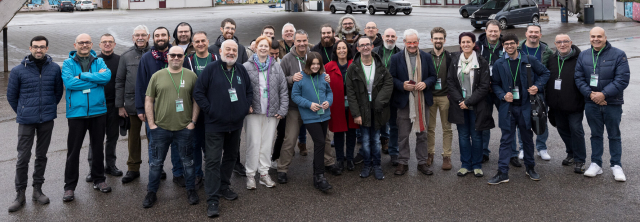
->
[[242, 57, 289, 117]]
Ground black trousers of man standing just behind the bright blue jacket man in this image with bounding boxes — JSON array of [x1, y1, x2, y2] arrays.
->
[[87, 103, 120, 167]]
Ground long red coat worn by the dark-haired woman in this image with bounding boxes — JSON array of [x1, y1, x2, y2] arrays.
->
[[324, 60, 360, 133]]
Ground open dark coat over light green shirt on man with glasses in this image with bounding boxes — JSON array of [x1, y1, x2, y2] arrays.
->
[[347, 52, 393, 129]]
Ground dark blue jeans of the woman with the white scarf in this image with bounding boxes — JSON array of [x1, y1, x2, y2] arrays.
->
[[456, 110, 483, 170]]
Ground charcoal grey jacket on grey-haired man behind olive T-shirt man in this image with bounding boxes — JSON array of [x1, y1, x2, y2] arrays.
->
[[112, 44, 150, 115]]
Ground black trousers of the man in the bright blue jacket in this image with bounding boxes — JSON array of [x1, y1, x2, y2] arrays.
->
[[64, 115, 107, 190]]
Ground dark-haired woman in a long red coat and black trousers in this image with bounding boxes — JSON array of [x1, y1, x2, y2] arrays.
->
[[324, 40, 359, 172]]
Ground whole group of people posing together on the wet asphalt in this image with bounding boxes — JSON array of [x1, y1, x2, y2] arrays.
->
[[7, 15, 630, 217]]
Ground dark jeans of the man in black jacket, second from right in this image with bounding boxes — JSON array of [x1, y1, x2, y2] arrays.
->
[[555, 111, 587, 163]]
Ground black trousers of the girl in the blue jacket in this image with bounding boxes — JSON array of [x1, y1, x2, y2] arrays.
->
[[304, 121, 329, 175]]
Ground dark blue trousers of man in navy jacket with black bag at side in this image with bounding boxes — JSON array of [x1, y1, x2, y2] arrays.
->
[[498, 105, 536, 173]]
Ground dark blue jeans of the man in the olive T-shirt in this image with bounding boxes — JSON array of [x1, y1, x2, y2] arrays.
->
[[147, 127, 195, 192]]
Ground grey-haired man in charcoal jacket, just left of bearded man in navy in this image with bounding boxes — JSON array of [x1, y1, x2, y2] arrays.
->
[[112, 25, 150, 183]]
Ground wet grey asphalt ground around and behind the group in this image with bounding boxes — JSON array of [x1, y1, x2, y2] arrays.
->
[[0, 5, 640, 221]]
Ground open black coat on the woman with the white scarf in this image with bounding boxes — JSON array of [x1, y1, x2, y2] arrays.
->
[[447, 52, 496, 131]]
